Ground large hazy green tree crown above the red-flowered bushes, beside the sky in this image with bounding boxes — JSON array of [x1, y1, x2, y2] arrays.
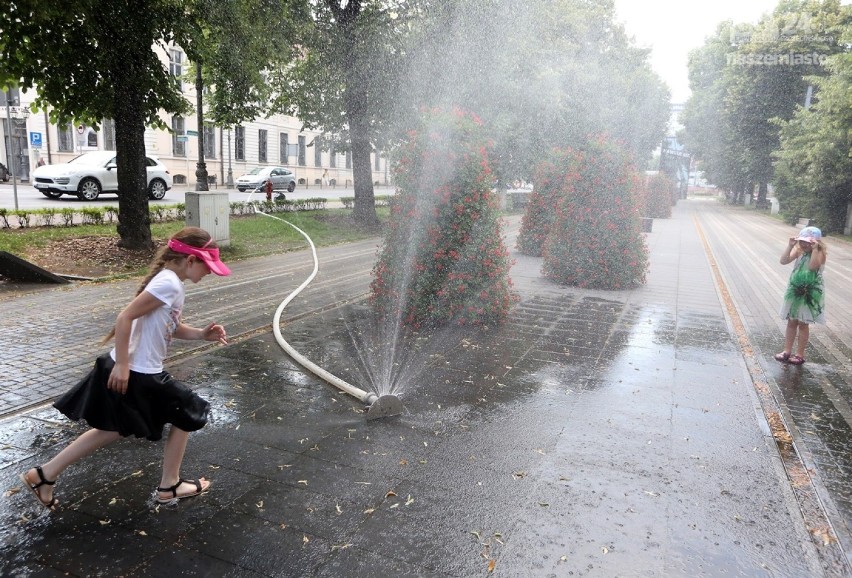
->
[[402, 0, 669, 180]]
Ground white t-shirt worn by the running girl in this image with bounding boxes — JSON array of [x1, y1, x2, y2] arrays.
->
[[110, 269, 185, 373]]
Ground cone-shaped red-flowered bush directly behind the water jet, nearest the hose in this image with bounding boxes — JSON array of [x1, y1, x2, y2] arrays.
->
[[370, 110, 511, 328]]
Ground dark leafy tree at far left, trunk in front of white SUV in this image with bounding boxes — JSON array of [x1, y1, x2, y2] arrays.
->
[[0, 0, 192, 248]]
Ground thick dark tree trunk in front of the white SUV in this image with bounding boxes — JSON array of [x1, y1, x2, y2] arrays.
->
[[115, 69, 154, 250]]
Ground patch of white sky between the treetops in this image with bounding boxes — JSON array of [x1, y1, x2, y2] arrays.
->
[[615, 0, 784, 103]]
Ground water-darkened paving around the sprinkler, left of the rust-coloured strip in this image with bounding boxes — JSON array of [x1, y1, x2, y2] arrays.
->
[[0, 296, 820, 576]]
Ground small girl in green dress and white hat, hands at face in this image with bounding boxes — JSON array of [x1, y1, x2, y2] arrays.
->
[[775, 227, 828, 365]]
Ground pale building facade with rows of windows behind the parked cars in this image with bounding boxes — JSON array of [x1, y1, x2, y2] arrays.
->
[[0, 46, 390, 188]]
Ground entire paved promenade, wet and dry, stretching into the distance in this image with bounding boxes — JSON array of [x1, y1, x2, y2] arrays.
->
[[0, 200, 852, 577]]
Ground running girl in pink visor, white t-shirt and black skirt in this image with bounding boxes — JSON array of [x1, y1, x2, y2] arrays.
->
[[20, 227, 231, 510]]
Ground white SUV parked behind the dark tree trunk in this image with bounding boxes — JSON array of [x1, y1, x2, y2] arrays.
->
[[32, 151, 172, 201]]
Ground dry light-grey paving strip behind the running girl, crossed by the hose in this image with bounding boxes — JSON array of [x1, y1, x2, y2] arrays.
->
[[0, 239, 378, 417]]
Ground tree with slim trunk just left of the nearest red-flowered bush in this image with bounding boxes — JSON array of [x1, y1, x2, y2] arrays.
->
[[270, 0, 415, 226]]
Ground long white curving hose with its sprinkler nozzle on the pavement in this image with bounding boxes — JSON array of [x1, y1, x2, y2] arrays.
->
[[249, 195, 402, 420]]
